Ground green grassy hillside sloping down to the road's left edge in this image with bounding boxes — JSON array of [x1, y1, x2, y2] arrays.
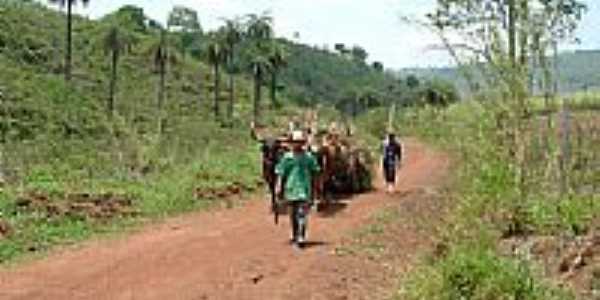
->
[[0, 0, 392, 262]]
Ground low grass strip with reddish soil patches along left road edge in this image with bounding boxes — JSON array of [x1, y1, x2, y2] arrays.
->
[[0, 123, 260, 263]]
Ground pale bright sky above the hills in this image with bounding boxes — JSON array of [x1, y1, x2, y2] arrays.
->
[[54, 0, 600, 69]]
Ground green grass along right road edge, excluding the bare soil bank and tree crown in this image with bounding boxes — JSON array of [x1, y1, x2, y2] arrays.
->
[[358, 101, 600, 299]]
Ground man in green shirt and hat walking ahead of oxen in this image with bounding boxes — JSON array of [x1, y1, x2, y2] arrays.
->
[[275, 131, 320, 246]]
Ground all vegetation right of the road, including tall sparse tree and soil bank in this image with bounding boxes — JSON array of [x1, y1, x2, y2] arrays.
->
[[360, 0, 600, 300]]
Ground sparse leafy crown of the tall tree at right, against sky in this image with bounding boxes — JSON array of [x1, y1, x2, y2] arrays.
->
[[427, 0, 586, 94]]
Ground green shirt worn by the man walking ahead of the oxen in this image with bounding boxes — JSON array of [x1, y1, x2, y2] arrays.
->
[[275, 152, 320, 201]]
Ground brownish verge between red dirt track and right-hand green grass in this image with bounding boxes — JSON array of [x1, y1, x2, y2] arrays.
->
[[334, 182, 450, 300]]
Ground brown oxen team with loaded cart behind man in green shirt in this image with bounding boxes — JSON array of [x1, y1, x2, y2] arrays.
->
[[252, 118, 372, 220]]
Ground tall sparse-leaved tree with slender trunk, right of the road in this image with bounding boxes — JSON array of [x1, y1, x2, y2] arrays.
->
[[429, 0, 586, 199]]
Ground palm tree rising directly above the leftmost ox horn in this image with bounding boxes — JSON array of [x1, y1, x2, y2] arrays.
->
[[246, 14, 273, 124]]
